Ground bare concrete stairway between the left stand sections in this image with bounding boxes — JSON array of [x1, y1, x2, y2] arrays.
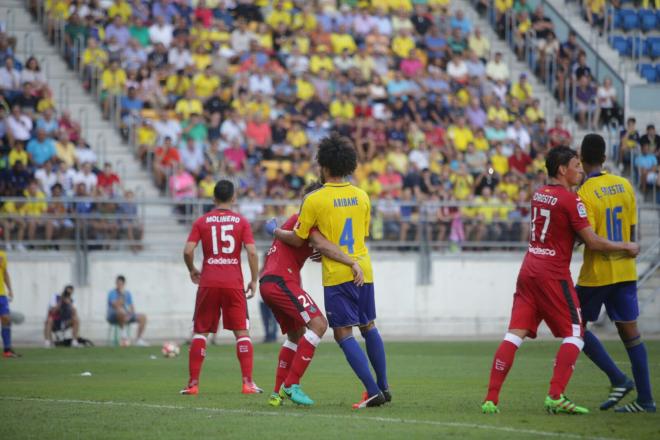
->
[[0, 0, 185, 250]]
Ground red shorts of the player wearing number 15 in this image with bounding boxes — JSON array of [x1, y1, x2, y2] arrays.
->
[[193, 287, 250, 333]]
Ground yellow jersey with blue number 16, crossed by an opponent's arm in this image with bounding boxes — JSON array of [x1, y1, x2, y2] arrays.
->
[[578, 173, 637, 287]]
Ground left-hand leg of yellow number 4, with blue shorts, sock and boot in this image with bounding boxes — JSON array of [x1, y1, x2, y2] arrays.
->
[[324, 282, 385, 408]]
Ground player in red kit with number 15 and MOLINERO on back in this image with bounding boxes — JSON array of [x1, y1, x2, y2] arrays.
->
[[181, 180, 263, 394]]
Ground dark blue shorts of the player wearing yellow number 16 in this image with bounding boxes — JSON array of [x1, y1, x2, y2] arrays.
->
[[575, 281, 639, 322]]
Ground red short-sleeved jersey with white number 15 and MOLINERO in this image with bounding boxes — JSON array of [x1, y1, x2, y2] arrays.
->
[[188, 209, 254, 289]]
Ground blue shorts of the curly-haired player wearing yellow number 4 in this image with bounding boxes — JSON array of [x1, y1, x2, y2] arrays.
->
[[323, 281, 376, 328]]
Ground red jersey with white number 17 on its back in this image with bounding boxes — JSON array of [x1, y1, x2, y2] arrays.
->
[[520, 185, 589, 279]]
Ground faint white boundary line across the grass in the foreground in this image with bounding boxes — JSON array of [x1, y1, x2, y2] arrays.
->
[[0, 396, 618, 440]]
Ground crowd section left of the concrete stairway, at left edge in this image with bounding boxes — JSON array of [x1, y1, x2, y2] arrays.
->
[[0, 24, 141, 250]]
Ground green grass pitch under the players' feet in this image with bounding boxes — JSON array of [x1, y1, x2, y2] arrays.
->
[[0, 341, 660, 440]]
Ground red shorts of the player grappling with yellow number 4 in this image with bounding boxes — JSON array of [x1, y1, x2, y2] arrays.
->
[[259, 275, 323, 334]]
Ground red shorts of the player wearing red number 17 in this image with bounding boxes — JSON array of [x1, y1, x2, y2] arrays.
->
[[509, 275, 582, 338]]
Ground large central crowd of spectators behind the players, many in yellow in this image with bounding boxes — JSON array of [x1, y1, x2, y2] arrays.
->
[[37, 0, 592, 246]]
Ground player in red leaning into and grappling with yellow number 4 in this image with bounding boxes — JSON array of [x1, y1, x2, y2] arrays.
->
[[259, 184, 364, 406]]
